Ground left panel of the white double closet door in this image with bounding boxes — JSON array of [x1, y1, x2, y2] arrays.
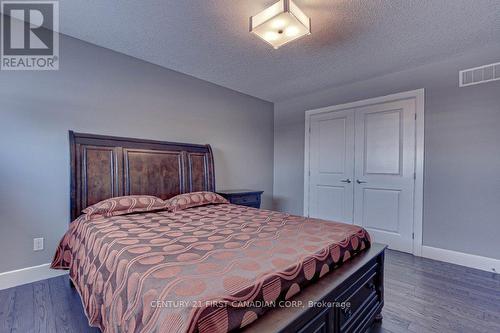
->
[[306, 110, 354, 223]]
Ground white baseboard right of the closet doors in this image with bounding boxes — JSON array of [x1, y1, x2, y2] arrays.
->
[[422, 245, 500, 273]]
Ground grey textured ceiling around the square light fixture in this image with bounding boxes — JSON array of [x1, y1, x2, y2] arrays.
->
[[60, 0, 500, 102]]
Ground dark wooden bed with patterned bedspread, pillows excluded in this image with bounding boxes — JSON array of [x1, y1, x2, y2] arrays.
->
[[52, 132, 385, 332]]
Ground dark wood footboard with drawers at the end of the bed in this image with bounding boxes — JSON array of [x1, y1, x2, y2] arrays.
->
[[244, 244, 386, 333]]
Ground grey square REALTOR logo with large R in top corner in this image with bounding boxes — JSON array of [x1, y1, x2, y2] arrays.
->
[[0, 0, 59, 70]]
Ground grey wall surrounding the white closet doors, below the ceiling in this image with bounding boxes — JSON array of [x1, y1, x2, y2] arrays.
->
[[274, 45, 500, 259]]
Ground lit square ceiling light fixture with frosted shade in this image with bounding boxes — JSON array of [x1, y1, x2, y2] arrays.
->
[[250, 0, 311, 49]]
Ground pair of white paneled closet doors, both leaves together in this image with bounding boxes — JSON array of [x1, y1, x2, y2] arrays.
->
[[306, 99, 416, 253]]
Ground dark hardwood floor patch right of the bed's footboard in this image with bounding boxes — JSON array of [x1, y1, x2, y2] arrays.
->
[[371, 251, 500, 333]]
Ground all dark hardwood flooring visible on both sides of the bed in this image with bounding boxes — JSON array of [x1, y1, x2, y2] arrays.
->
[[0, 251, 500, 333]]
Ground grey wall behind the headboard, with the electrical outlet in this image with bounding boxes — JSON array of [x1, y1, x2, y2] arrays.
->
[[0, 37, 273, 272]]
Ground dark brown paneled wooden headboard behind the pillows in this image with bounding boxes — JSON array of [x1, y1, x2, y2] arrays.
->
[[69, 131, 215, 220]]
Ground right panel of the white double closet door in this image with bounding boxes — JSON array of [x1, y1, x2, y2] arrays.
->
[[354, 100, 415, 253]]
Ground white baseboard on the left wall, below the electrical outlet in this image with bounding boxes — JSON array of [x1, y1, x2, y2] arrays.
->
[[0, 264, 68, 290]]
